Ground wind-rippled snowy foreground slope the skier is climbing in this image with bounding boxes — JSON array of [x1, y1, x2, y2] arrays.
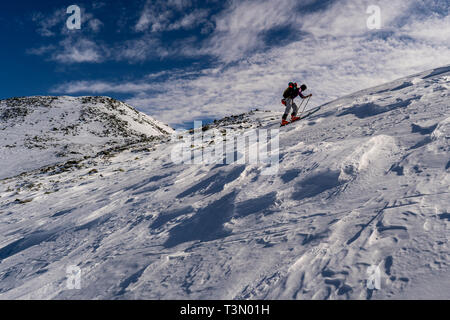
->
[[0, 67, 450, 299]]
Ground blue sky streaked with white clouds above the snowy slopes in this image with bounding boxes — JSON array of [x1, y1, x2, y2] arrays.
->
[[0, 0, 450, 127]]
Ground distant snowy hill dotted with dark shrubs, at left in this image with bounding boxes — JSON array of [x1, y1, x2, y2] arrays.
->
[[0, 97, 172, 178]]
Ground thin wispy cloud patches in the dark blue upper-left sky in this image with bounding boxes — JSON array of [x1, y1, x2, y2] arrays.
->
[[27, 0, 209, 63]]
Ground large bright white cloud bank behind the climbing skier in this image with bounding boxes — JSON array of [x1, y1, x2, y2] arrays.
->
[[51, 0, 450, 125]]
